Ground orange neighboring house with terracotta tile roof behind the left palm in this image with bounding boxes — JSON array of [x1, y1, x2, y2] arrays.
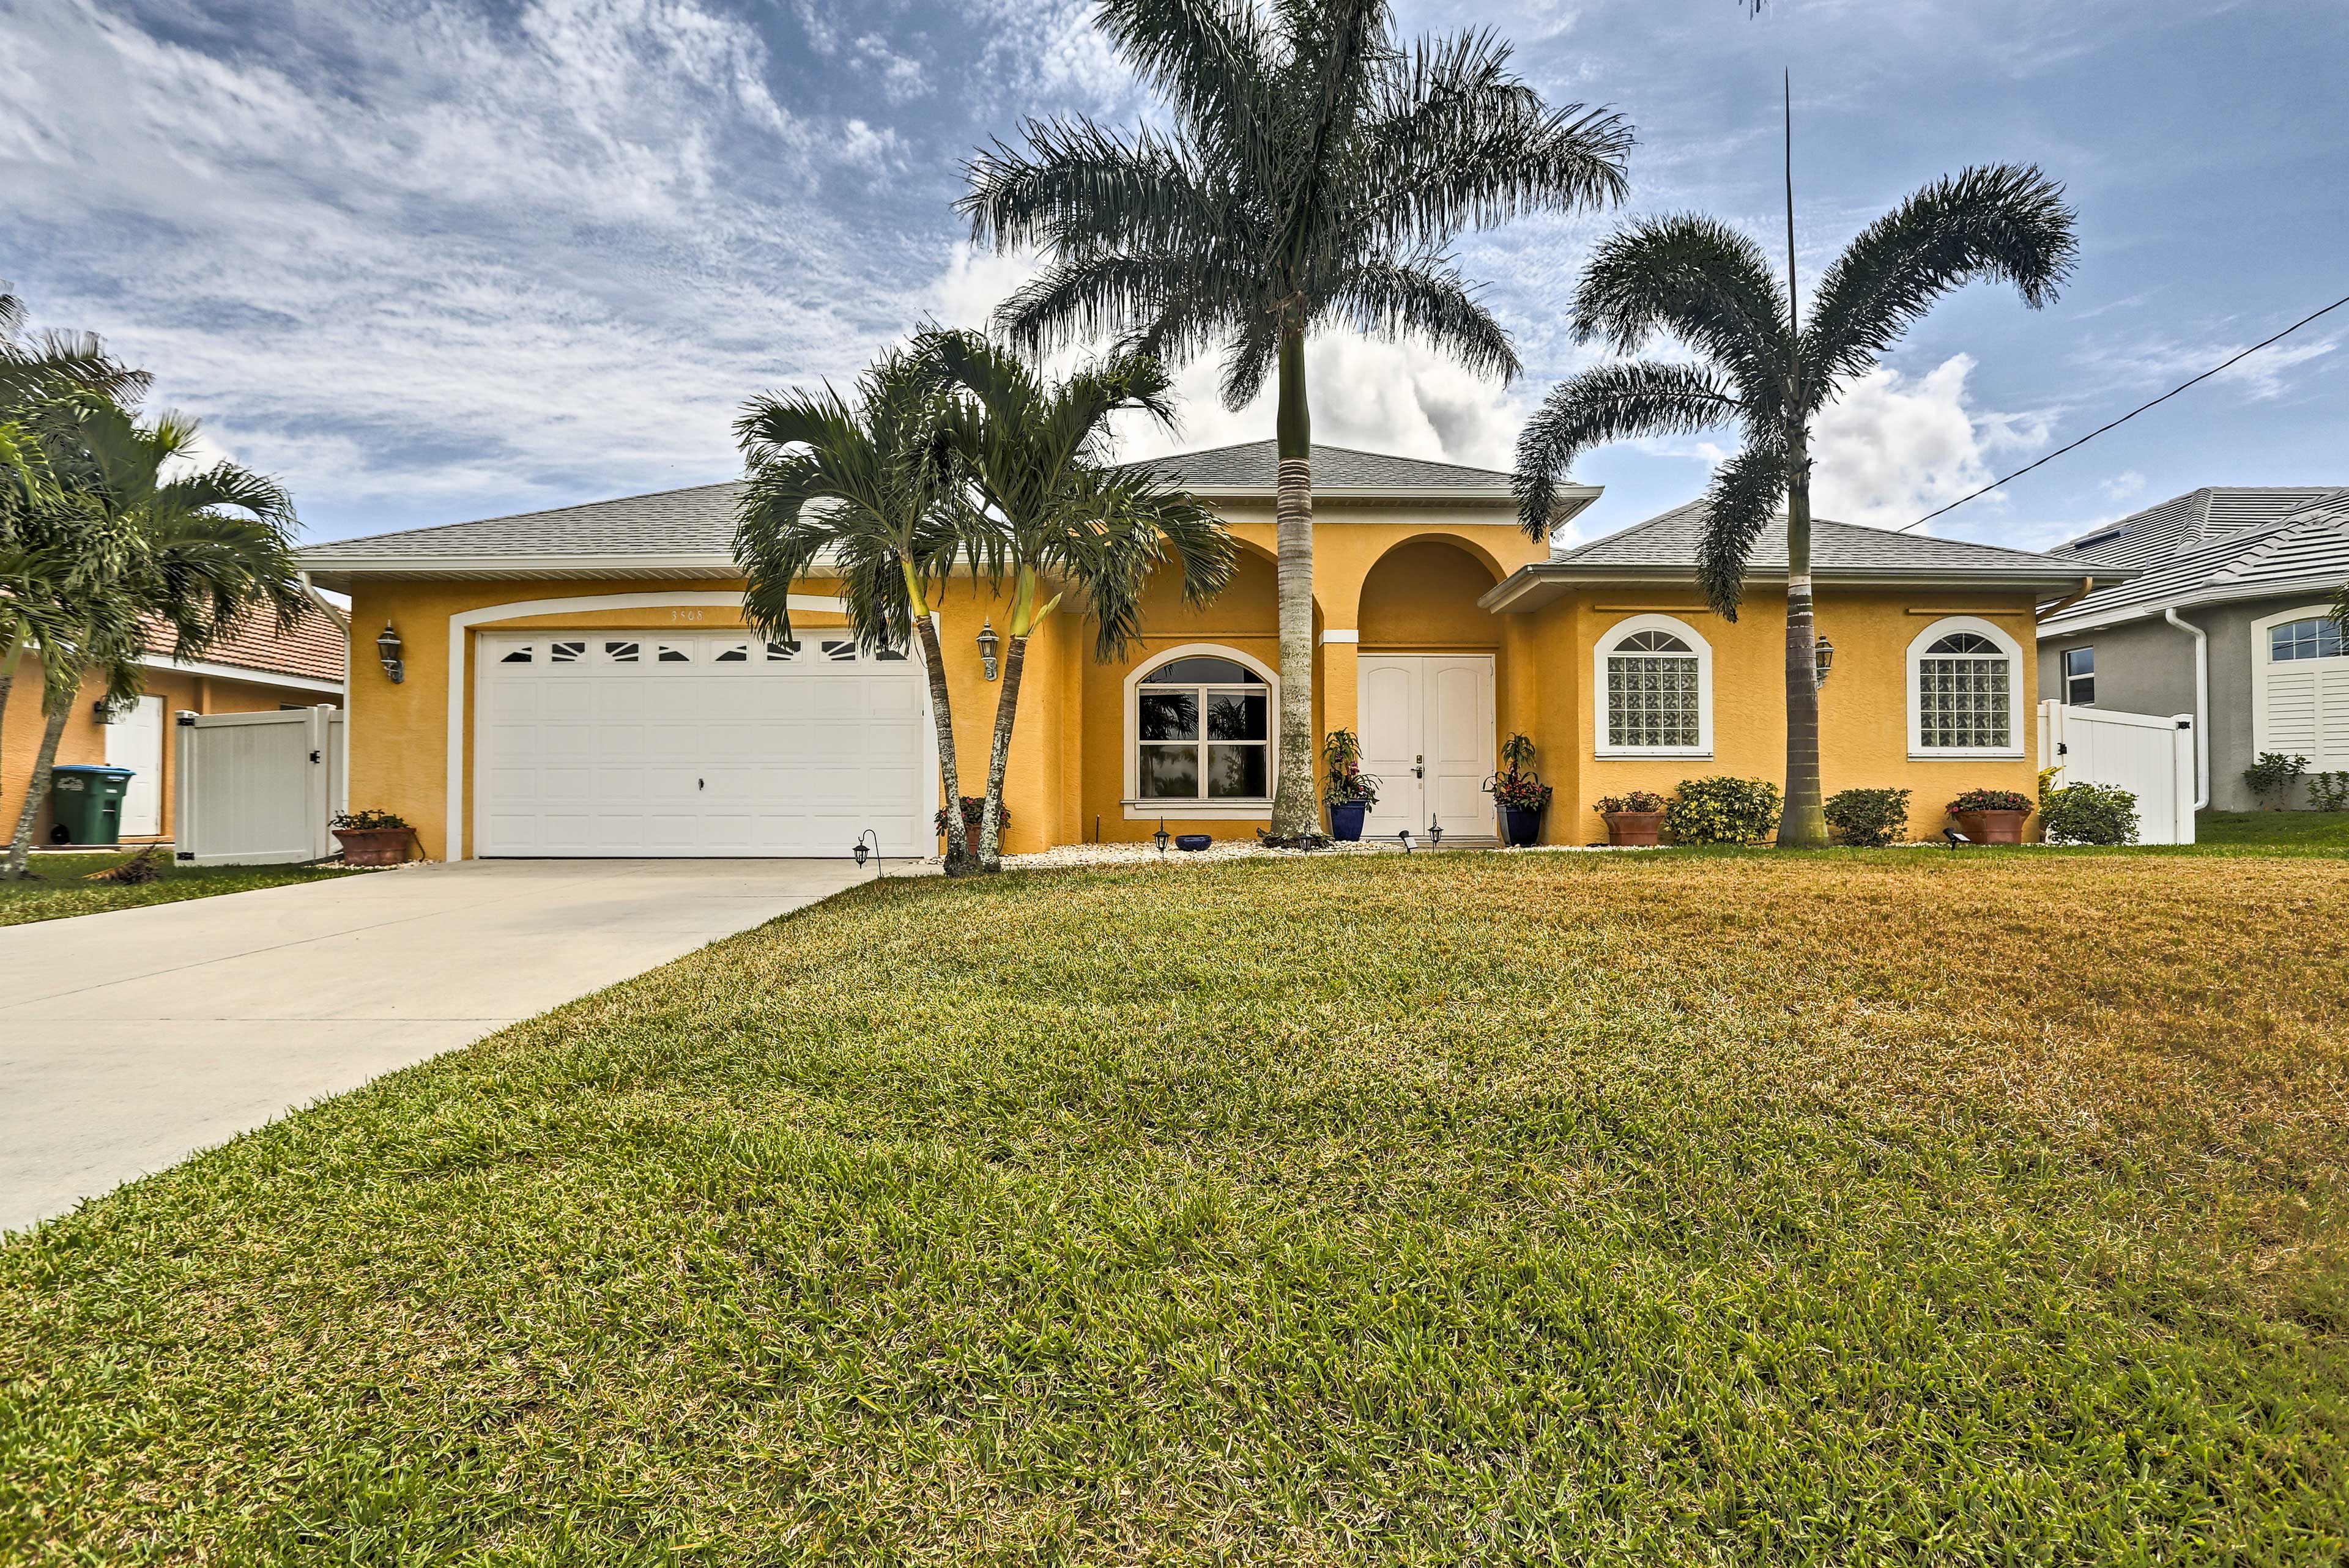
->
[[0, 610, 343, 845]]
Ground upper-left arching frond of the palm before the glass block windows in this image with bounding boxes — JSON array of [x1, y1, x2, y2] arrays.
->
[[1574, 213, 1792, 409]]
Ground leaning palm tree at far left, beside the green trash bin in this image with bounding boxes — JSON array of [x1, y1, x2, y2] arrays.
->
[[5, 390, 308, 880]]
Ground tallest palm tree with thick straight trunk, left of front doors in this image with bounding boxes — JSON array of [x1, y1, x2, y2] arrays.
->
[[961, 0, 1630, 843]]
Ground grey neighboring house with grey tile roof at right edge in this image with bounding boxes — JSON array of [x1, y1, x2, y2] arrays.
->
[[2039, 486, 2349, 810]]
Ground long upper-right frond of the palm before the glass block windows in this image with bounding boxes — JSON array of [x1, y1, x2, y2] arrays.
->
[[1802, 165, 2079, 409]]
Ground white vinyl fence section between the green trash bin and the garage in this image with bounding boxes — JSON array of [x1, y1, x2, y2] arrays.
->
[[171, 706, 347, 866]]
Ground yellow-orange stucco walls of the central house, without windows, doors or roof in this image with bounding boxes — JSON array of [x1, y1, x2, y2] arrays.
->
[[350, 509, 2036, 857]]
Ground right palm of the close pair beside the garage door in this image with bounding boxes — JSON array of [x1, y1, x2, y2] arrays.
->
[[916, 331, 1236, 871]]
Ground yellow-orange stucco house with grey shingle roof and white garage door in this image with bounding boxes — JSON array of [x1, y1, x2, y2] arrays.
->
[[303, 442, 2102, 859]]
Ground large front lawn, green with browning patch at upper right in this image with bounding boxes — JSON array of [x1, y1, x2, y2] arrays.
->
[[0, 852, 2349, 1566]]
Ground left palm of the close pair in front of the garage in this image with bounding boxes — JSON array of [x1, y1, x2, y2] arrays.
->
[[735, 350, 970, 876]]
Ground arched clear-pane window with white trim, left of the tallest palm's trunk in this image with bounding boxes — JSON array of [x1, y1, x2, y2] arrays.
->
[[1135, 655, 1273, 803]]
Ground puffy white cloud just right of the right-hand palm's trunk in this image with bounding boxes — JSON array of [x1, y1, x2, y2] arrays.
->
[[1811, 355, 2050, 528]]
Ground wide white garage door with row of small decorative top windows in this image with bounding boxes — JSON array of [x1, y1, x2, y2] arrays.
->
[[475, 632, 937, 857]]
